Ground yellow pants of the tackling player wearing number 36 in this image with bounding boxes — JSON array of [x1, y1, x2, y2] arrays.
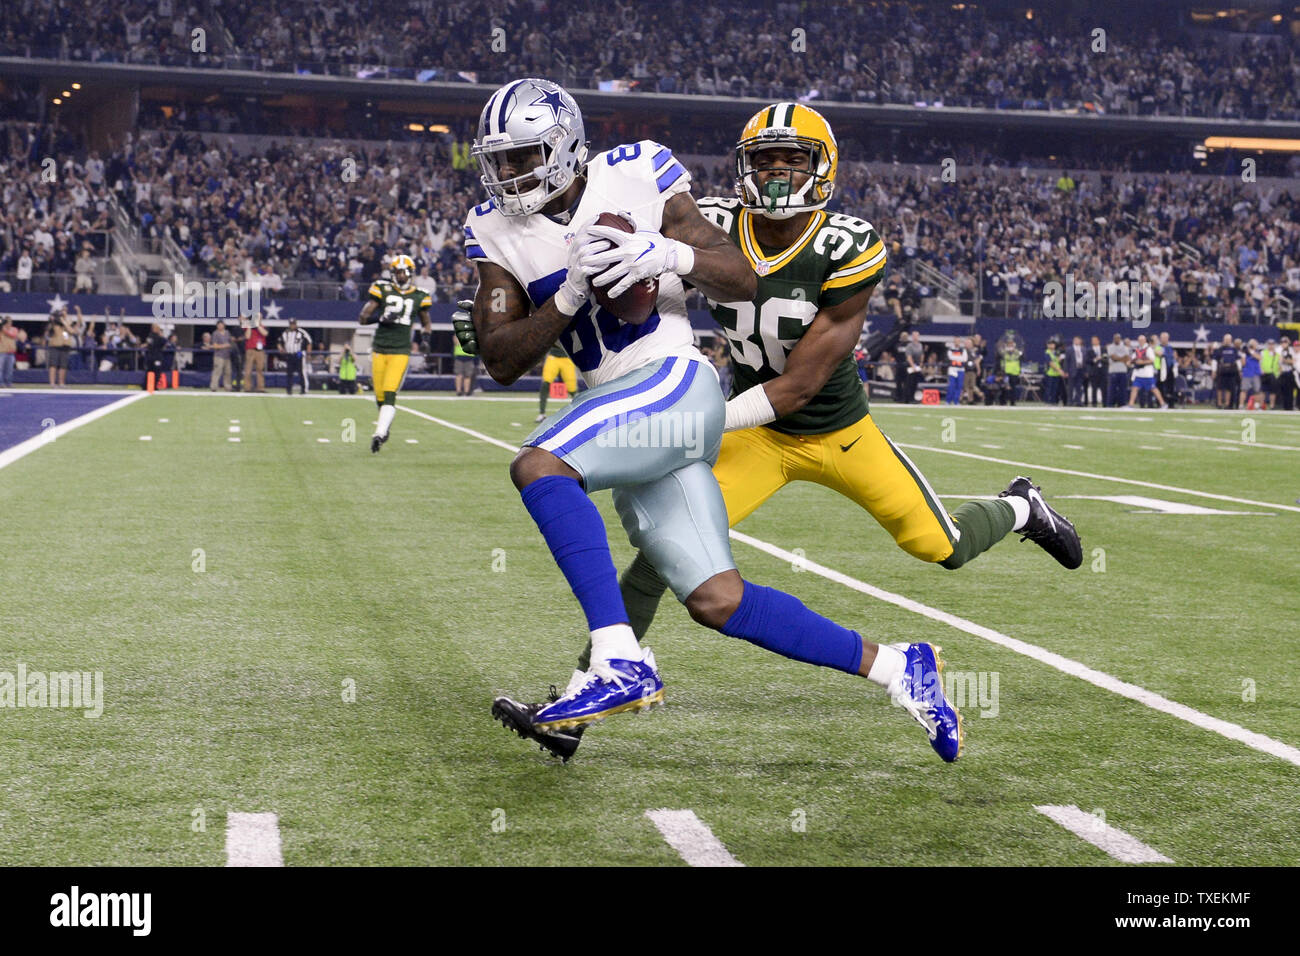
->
[[714, 415, 957, 562]]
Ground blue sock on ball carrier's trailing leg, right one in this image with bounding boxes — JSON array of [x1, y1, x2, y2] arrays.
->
[[722, 581, 862, 674]]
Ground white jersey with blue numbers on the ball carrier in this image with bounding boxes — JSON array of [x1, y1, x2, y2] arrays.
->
[[465, 139, 705, 388]]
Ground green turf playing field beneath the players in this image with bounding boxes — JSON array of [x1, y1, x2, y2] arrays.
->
[[0, 394, 1300, 866]]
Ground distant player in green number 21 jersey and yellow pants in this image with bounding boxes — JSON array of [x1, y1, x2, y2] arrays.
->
[[358, 255, 433, 451]]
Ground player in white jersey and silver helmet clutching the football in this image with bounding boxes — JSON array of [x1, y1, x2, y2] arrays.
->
[[460, 79, 961, 761]]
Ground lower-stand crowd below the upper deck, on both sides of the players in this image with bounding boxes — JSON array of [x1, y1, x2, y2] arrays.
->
[[0, 124, 1300, 323]]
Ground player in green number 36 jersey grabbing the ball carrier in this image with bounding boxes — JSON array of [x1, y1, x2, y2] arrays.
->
[[605, 103, 1083, 650]]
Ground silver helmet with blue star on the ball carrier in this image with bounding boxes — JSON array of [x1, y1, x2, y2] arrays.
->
[[473, 78, 586, 216]]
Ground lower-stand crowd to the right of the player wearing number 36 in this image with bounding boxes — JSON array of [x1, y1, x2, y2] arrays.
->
[[840, 168, 1300, 323]]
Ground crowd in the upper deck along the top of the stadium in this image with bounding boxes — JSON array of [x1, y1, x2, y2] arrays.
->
[[0, 0, 1300, 118]]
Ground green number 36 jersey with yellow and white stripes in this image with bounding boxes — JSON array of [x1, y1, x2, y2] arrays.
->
[[699, 196, 885, 434]]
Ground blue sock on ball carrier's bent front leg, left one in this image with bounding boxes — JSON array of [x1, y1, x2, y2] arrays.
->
[[520, 475, 628, 631]]
